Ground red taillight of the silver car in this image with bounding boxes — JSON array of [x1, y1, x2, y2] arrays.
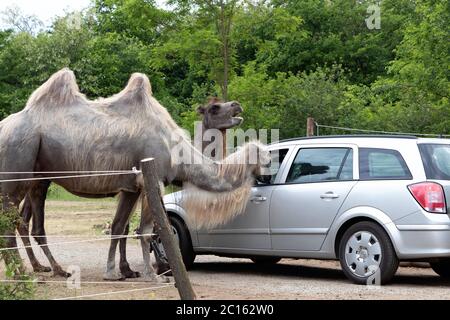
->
[[408, 182, 447, 213]]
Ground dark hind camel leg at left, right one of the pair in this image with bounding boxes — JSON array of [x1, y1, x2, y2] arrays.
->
[[27, 180, 70, 277]]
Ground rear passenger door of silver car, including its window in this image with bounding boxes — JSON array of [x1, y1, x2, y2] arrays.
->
[[270, 145, 357, 251]]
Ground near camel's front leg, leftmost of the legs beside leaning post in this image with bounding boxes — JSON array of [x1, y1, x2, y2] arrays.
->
[[103, 191, 140, 280]]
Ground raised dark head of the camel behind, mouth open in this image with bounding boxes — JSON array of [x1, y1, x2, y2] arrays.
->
[[197, 98, 243, 130]]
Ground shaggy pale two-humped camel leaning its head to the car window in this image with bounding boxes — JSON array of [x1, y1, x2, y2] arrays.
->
[[0, 69, 270, 280]]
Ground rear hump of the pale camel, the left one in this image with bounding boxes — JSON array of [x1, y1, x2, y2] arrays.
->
[[26, 68, 84, 108]]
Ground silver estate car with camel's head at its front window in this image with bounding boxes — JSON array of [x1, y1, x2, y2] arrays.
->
[[164, 136, 450, 284]]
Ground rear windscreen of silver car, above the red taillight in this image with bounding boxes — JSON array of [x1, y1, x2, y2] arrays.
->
[[419, 144, 450, 180]]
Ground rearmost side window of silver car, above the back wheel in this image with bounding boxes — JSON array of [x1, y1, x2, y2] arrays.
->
[[359, 148, 412, 180]]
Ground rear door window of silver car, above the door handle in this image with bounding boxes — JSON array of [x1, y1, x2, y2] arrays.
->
[[286, 148, 353, 183]]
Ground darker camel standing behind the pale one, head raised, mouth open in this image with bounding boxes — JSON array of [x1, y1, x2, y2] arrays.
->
[[17, 98, 243, 278]]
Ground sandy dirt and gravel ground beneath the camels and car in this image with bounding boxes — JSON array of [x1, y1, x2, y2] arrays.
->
[[0, 201, 450, 300]]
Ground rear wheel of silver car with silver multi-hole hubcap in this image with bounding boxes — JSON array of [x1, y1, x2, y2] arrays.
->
[[339, 221, 399, 284]]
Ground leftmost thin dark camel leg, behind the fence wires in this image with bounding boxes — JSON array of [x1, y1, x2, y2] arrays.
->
[[17, 195, 52, 272]]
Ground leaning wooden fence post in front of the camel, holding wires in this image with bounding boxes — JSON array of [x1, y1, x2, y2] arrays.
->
[[141, 158, 196, 300]]
